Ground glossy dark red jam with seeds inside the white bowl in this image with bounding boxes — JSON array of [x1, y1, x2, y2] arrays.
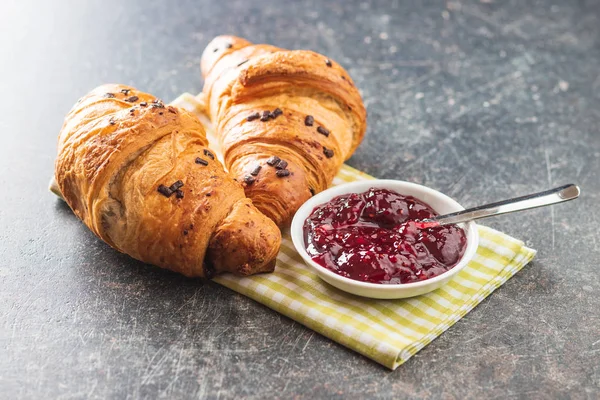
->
[[304, 188, 467, 284]]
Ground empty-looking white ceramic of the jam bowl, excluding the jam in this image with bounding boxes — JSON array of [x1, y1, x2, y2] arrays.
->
[[290, 179, 479, 299]]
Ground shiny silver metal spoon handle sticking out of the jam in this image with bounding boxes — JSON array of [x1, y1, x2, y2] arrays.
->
[[423, 184, 580, 227]]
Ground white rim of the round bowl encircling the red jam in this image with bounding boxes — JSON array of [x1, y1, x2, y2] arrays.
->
[[290, 179, 479, 292]]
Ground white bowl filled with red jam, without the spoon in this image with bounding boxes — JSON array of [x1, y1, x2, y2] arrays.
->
[[291, 180, 478, 299]]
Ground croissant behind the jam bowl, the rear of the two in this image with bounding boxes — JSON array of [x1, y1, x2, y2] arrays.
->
[[201, 36, 366, 226]]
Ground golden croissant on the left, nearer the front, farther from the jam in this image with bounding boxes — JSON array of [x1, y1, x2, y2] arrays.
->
[[55, 85, 281, 278]]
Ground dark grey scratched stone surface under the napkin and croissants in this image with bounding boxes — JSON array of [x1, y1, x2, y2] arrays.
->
[[0, 0, 600, 399]]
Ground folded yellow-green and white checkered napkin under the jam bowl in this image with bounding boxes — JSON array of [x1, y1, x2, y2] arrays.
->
[[51, 93, 536, 369]]
